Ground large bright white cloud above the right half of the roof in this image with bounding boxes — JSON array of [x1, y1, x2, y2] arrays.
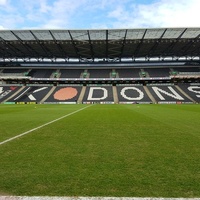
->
[[108, 0, 200, 28]]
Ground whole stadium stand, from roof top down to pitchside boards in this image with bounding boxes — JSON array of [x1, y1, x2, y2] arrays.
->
[[0, 28, 200, 104]]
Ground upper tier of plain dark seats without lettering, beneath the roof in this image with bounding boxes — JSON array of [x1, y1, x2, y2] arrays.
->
[[0, 66, 200, 78]]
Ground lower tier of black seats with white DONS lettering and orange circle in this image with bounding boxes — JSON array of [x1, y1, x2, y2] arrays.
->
[[0, 83, 200, 103]]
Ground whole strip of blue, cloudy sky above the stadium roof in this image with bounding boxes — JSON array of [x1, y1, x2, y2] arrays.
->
[[0, 0, 200, 29]]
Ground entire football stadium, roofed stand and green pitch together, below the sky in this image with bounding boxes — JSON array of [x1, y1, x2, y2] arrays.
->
[[0, 28, 200, 199]]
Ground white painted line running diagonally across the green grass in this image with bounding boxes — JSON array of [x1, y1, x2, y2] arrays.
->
[[0, 105, 92, 145]]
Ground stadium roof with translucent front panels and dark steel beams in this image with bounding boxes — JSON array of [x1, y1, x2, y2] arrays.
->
[[0, 28, 200, 61]]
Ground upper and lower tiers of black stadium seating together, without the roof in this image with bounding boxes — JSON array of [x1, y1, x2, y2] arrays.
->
[[0, 66, 200, 104]]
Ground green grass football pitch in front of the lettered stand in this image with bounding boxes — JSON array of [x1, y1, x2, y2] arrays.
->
[[0, 104, 200, 197]]
